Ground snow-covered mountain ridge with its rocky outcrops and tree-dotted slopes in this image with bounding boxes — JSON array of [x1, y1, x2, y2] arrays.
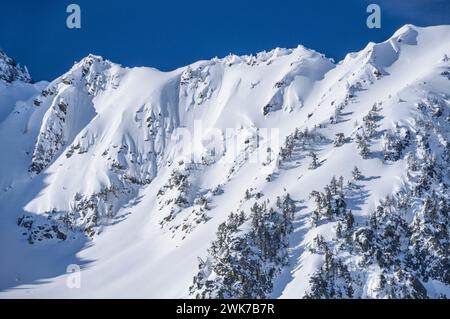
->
[[0, 25, 450, 298]]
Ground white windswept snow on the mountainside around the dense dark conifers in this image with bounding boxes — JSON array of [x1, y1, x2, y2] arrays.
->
[[0, 25, 450, 298]]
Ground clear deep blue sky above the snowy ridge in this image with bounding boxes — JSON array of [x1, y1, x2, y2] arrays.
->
[[0, 0, 450, 80]]
